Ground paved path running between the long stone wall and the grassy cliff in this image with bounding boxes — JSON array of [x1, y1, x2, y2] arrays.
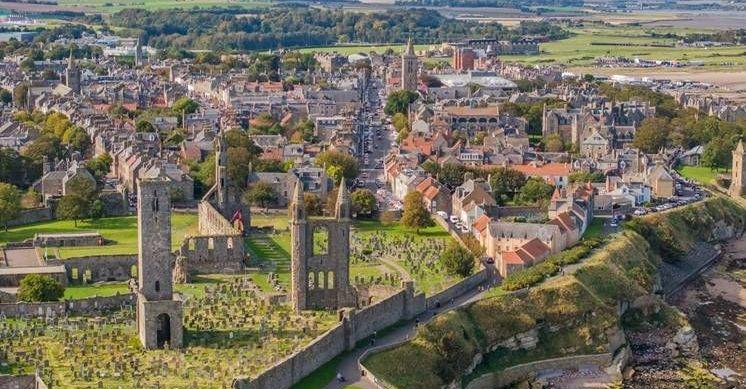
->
[[326, 278, 489, 389]]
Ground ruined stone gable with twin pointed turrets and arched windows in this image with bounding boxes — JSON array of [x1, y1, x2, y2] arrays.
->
[[289, 179, 357, 311]]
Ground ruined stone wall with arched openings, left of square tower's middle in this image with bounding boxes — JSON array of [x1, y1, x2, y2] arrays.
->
[[47, 254, 137, 284]]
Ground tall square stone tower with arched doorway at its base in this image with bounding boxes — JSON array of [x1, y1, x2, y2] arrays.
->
[[137, 168, 183, 349]]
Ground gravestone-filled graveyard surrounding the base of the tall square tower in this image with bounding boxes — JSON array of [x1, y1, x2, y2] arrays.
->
[[0, 276, 336, 387]]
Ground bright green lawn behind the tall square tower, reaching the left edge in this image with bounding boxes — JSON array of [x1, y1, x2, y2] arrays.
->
[[0, 213, 197, 258]]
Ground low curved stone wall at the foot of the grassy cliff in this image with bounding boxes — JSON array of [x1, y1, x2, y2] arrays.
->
[[466, 353, 614, 389]]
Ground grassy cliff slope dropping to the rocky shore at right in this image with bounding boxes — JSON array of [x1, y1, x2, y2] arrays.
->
[[364, 199, 746, 388]]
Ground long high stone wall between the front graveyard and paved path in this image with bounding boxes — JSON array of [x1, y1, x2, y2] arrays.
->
[[232, 282, 425, 389]]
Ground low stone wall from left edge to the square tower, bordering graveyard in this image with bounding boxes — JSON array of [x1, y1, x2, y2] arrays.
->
[[0, 293, 137, 316]]
